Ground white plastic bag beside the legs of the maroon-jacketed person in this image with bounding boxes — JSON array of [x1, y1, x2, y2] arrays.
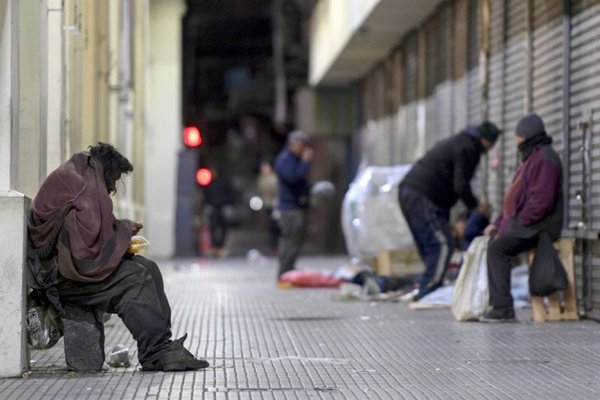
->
[[451, 236, 489, 321]]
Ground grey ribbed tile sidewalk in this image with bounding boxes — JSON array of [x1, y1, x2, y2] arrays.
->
[[0, 258, 600, 400]]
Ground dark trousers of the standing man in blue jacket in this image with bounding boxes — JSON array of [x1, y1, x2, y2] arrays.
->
[[278, 208, 307, 276]]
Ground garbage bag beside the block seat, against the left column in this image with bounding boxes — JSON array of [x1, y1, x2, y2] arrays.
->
[[25, 291, 63, 350]]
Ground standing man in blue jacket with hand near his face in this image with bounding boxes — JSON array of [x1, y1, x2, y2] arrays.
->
[[275, 131, 314, 277]]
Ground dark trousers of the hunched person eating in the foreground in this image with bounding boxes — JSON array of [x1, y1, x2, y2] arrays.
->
[[58, 256, 171, 364]]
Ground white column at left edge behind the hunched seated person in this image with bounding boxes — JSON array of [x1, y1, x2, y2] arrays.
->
[[0, 0, 29, 377]]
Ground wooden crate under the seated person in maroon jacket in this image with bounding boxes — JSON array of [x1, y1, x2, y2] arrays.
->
[[529, 239, 579, 322]]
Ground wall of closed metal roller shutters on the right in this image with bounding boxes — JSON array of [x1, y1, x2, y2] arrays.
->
[[356, 0, 600, 315]]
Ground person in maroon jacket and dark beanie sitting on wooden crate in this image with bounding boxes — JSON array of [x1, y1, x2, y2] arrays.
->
[[480, 114, 563, 322]]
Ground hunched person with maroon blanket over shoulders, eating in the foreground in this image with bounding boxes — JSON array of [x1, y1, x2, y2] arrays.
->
[[27, 143, 208, 371]]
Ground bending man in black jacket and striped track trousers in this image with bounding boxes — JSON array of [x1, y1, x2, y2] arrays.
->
[[399, 122, 500, 300]]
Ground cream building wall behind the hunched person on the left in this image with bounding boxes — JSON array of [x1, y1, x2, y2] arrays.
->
[[2, 0, 149, 219]]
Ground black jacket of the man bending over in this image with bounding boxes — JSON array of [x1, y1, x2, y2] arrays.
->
[[401, 127, 484, 213]]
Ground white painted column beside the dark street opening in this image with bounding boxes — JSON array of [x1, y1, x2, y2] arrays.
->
[[145, 0, 185, 257]]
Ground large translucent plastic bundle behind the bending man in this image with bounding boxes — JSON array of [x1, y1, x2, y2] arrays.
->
[[342, 165, 414, 260]]
